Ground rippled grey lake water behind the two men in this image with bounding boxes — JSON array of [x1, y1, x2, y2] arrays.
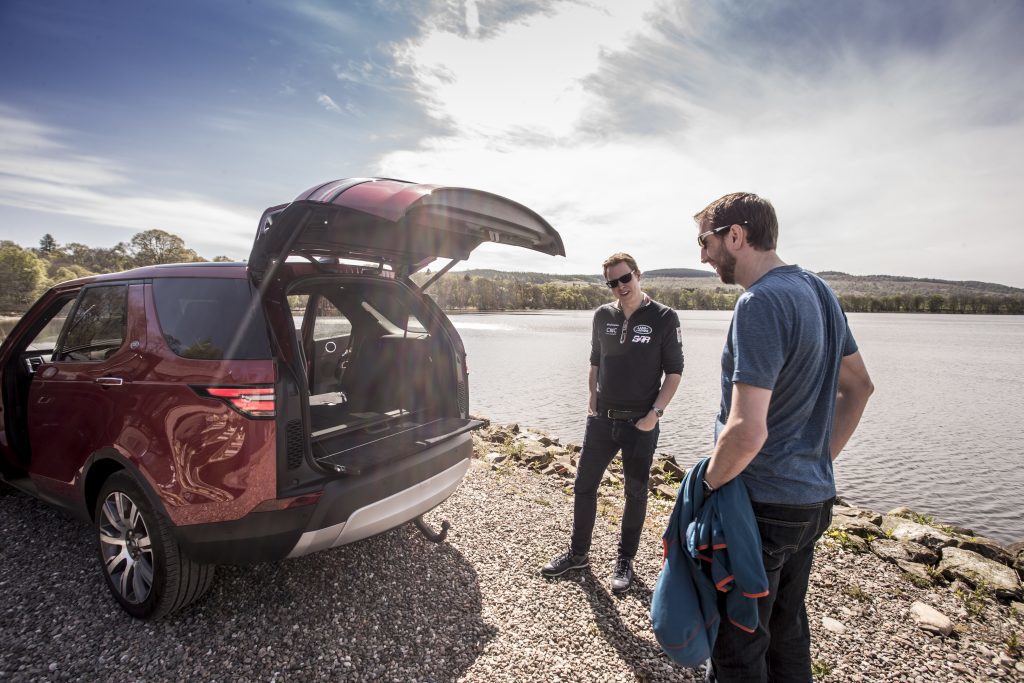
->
[[452, 311, 1024, 542]]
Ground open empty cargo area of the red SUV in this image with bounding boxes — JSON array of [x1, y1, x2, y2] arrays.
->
[[288, 278, 481, 475]]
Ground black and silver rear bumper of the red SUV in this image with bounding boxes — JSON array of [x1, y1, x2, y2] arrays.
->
[[175, 433, 473, 564]]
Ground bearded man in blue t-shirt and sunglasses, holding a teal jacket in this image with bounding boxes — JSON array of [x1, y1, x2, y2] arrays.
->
[[694, 193, 873, 683]]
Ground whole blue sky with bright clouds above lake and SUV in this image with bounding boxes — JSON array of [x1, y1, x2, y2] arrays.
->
[[0, 0, 1024, 287]]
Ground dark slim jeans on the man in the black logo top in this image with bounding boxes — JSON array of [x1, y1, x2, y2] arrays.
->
[[570, 415, 659, 559]]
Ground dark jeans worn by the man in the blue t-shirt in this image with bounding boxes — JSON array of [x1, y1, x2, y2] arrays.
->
[[709, 500, 833, 683]]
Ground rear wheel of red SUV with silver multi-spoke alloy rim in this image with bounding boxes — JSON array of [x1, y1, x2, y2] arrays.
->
[[93, 471, 216, 620]]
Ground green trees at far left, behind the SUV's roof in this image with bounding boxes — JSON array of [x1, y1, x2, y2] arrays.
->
[[0, 229, 234, 313]]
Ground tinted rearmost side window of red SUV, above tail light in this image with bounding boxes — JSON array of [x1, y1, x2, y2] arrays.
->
[[153, 278, 270, 360]]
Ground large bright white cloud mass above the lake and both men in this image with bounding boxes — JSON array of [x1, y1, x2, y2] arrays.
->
[[380, 2, 1024, 286]]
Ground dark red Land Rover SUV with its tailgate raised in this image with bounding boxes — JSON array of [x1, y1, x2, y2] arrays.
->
[[0, 178, 564, 618]]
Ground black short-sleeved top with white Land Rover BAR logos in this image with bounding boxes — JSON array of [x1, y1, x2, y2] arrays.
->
[[590, 299, 683, 411]]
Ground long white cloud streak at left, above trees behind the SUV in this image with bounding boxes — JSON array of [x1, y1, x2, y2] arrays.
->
[[0, 105, 259, 255]]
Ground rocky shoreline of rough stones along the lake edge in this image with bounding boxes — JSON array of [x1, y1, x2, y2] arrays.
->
[[473, 418, 1024, 680]]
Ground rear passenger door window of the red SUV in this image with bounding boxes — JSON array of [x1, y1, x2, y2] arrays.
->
[[54, 285, 128, 361]]
